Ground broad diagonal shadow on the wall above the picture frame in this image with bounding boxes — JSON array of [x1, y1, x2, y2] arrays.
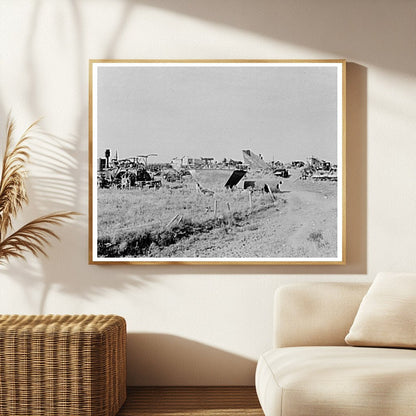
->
[[136, 0, 415, 75]]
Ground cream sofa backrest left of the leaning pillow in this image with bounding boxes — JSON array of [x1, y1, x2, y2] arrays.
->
[[273, 283, 370, 348]]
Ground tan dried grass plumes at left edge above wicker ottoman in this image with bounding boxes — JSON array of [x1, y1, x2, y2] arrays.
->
[[0, 116, 78, 264]]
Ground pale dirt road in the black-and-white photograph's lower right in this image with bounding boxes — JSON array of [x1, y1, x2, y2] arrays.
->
[[155, 179, 337, 258]]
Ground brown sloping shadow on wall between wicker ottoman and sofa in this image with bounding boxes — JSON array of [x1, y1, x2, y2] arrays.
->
[[127, 333, 256, 386]]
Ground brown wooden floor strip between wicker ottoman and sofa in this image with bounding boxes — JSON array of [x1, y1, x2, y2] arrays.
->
[[117, 387, 264, 416]]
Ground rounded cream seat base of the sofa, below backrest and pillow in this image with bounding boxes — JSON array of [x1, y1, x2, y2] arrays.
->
[[256, 346, 416, 416]]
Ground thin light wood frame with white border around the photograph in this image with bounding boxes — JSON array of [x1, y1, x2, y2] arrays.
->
[[89, 59, 346, 265]]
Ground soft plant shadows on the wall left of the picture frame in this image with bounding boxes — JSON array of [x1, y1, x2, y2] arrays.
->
[[0, 0, 156, 313]]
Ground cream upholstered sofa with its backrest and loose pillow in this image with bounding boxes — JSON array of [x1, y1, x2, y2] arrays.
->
[[256, 274, 416, 416]]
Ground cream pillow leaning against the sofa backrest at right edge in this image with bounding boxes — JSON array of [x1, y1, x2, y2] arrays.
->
[[345, 273, 416, 348]]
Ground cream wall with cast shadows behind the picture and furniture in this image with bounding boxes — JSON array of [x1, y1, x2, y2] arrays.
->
[[0, 0, 416, 385]]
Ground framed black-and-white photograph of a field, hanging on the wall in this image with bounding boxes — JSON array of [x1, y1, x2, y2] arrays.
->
[[89, 60, 346, 265]]
